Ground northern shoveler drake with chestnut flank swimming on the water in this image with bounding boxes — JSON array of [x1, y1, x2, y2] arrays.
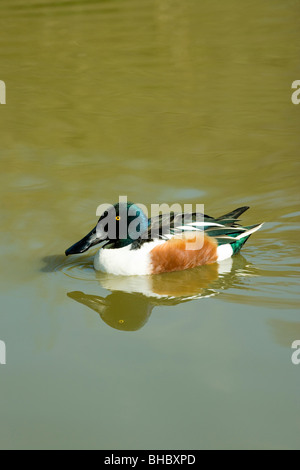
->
[[66, 202, 262, 276]]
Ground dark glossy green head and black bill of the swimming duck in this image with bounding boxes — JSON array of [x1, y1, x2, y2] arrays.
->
[[66, 202, 149, 256]]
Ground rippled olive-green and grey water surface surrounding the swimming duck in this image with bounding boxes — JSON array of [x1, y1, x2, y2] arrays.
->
[[0, 0, 300, 449]]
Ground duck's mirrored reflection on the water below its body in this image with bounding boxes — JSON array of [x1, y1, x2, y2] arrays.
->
[[68, 256, 258, 331]]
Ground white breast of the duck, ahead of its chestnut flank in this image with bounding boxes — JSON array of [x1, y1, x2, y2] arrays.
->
[[94, 240, 165, 276]]
